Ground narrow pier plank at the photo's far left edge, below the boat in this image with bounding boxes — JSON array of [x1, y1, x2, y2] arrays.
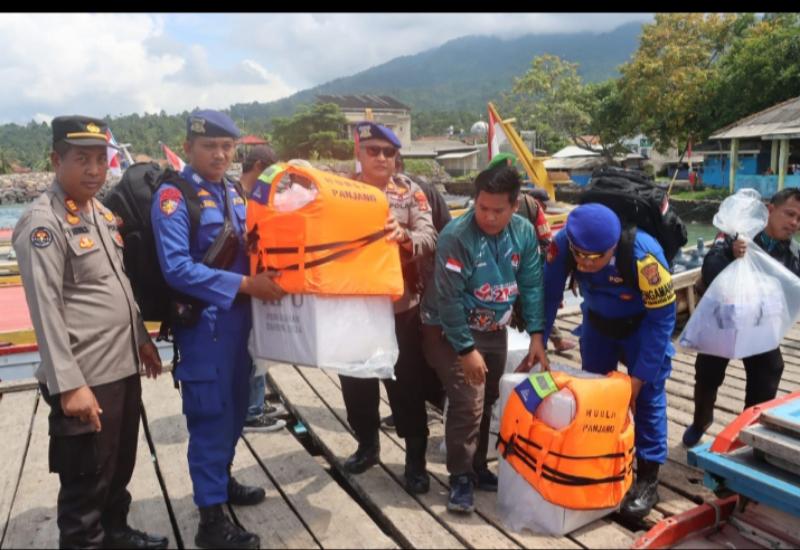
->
[[0, 391, 36, 541]]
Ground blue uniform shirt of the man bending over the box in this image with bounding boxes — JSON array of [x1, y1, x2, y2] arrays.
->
[[544, 230, 675, 382]]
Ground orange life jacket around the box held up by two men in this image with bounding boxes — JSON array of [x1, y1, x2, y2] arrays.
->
[[247, 164, 403, 299]]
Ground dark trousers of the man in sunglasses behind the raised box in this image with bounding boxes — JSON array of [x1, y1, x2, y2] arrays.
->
[[339, 306, 429, 441]]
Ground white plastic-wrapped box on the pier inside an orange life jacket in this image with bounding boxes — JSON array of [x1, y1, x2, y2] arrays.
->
[[497, 365, 617, 535]]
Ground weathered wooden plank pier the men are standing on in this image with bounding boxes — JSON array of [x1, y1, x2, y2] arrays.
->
[[0, 313, 800, 548]]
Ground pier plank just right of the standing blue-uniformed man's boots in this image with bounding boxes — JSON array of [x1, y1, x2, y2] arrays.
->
[[227, 438, 320, 548]]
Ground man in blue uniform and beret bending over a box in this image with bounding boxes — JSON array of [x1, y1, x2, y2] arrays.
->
[[544, 203, 675, 518]]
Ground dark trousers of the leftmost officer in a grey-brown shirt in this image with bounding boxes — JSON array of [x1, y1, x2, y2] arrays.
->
[[40, 374, 142, 548]]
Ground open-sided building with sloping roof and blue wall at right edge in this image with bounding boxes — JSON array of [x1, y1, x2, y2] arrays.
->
[[702, 97, 800, 197]]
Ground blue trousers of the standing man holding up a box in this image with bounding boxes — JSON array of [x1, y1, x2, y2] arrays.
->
[[176, 306, 252, 507]]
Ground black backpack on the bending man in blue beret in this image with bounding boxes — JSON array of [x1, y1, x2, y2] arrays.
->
[[569, 167, 688, 288]]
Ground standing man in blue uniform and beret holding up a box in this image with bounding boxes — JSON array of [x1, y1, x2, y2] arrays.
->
[[151, 110, 283, 548]]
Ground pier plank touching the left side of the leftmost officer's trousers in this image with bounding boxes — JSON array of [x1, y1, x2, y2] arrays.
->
[[3, 397, 59, 548]]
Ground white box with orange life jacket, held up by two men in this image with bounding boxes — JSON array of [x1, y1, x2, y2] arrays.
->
[[247, 164, 403, 378]]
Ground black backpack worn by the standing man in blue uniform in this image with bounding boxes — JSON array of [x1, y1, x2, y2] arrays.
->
[[103, 162, 200, 329]]
